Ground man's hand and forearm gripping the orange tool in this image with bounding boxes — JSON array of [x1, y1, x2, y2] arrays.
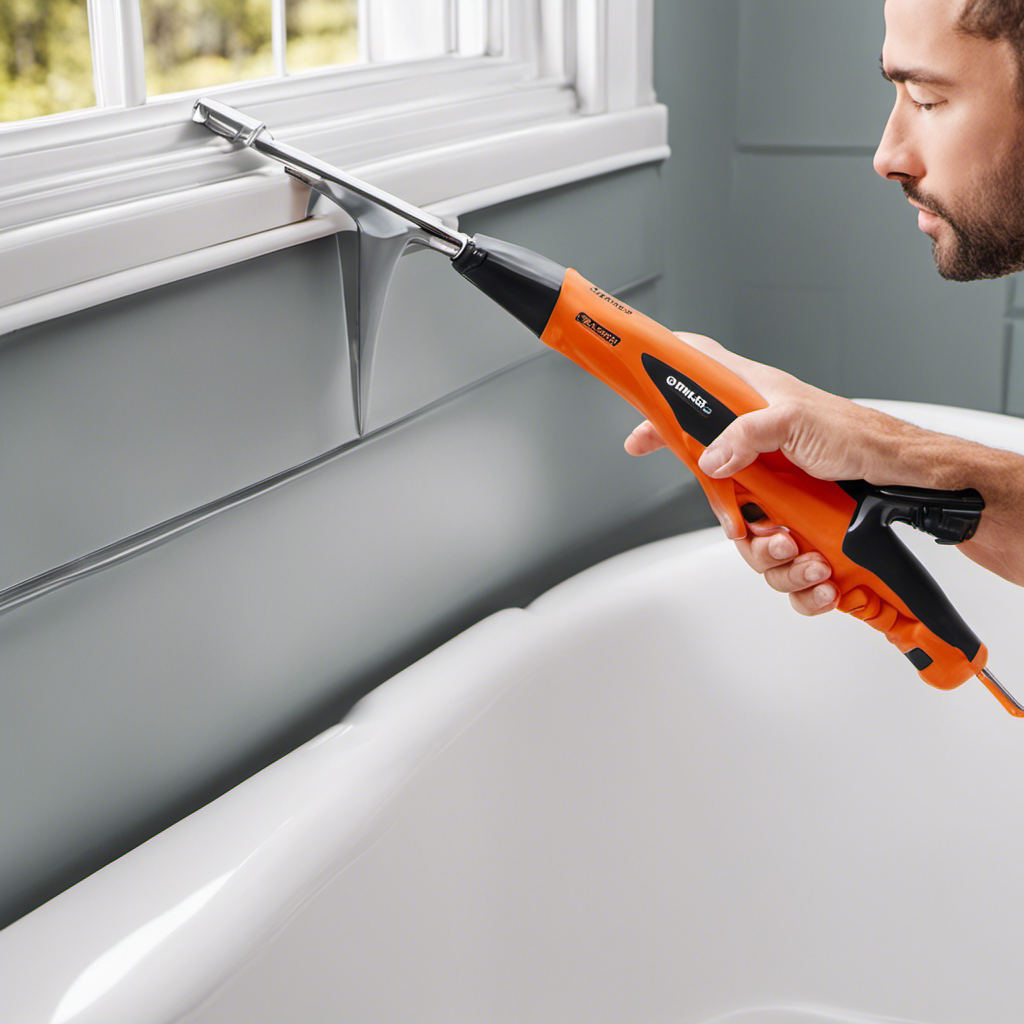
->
[[626, 334, 1024, 615]]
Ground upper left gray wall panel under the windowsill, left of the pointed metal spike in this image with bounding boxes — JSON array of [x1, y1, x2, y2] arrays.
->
[[0, 238, 355, 590]]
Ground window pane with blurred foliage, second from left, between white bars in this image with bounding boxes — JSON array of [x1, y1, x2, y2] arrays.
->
[[141, 0, 274, 96]]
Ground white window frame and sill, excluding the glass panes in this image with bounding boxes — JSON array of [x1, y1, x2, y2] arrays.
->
[[0, 0, 669, 334]]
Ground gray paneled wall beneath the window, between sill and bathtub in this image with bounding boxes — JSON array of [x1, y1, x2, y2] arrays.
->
[[0, 166, 710, 923]]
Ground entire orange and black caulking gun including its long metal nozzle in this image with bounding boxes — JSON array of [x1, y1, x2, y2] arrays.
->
[[191, 97, 1024, 717]]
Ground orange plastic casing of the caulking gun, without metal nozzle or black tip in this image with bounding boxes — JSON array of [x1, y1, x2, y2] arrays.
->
[[541, 270, 987, 689]]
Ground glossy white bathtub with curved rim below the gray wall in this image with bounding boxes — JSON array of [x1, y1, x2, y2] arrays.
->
[[0, 402, 1024, 1024]]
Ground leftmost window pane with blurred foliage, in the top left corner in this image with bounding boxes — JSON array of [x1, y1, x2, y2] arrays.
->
[[0, 0, 96, 121]]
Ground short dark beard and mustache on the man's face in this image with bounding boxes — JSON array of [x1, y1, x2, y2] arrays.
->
[[902, 146, 1024, 281]]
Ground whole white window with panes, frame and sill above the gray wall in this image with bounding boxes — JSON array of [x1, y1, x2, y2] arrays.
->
[[0, 0, 668, 334]]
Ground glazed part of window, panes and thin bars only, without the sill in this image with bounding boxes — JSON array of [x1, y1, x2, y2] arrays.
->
[[0, 0, 501, 122]]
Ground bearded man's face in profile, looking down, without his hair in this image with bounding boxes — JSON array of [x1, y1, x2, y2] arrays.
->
[[874, 0, 1024, 281]]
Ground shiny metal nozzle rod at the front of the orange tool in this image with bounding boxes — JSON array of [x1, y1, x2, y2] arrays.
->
[[193, 96, 469, 259]]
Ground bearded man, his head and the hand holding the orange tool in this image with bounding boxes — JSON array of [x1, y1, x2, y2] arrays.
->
[[626, 0, 1024, 615]]
